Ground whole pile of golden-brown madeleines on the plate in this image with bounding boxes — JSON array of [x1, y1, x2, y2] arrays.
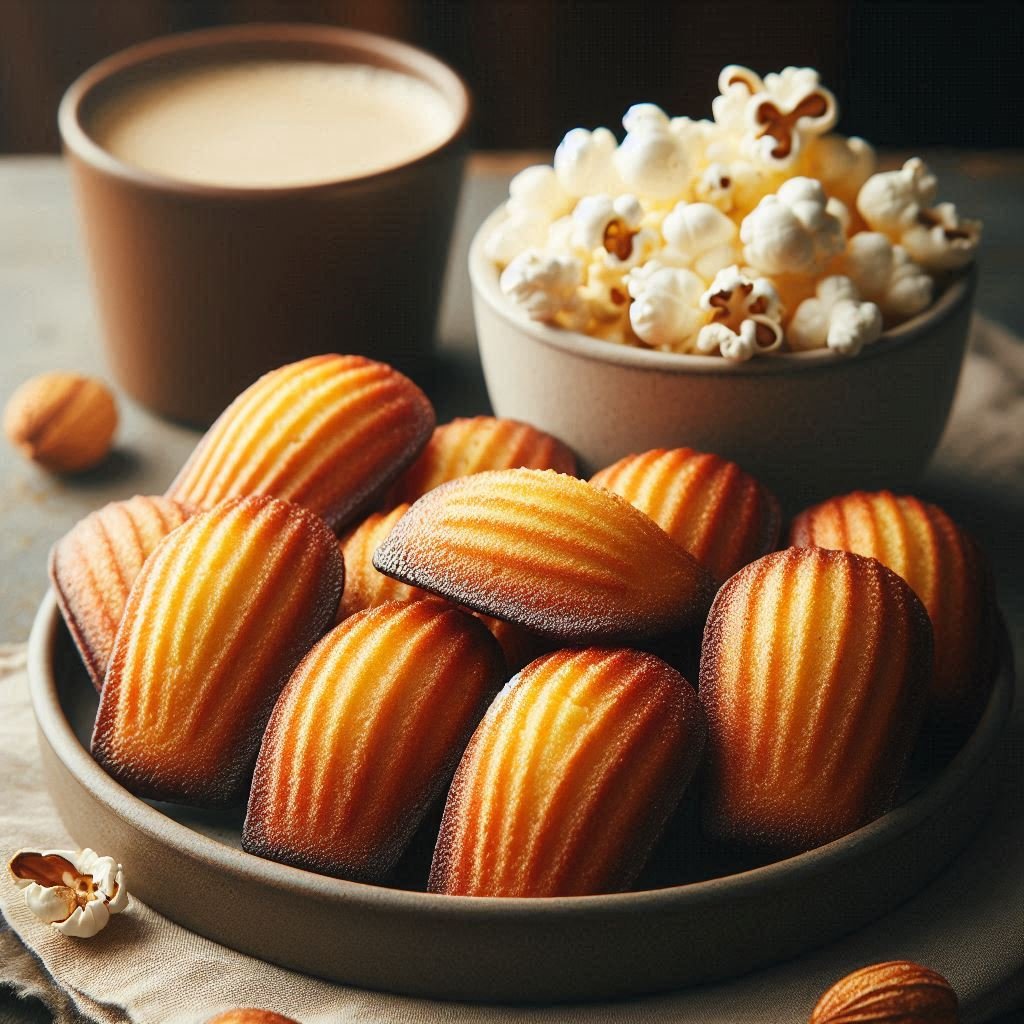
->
[[50, 355, 995, 896]]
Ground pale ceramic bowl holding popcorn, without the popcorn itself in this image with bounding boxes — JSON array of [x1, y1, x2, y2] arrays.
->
[[469, 208, 975, 510]]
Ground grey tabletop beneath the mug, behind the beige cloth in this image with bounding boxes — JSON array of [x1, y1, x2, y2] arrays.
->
[[0, 152, 1024, 1021]]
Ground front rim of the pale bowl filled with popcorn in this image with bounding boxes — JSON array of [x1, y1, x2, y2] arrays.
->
[[468, 203, 977, 377]]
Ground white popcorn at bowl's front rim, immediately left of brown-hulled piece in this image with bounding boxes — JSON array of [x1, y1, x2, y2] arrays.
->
[[627, 260, 707, 352]]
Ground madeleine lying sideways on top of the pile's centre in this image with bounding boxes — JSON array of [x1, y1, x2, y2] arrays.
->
[[374, 469, 714, 643]]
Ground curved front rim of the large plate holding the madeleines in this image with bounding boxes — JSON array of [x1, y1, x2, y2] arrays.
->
[[28, 588, 1014, 925]]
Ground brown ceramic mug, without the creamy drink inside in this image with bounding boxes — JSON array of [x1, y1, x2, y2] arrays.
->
[[66, 25, 470, 425]]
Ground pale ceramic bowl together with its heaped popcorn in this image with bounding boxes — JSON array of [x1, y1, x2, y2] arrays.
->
[[469, 66, 981, 504]]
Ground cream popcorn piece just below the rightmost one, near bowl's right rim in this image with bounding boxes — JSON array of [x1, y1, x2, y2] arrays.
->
[[838, 231, 935, 322]]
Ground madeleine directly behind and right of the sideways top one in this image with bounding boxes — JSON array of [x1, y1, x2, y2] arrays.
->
[[590, 447, 780, 582]]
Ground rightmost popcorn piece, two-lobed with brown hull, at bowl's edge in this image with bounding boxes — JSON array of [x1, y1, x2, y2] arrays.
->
[[857, 157, 981, 271]]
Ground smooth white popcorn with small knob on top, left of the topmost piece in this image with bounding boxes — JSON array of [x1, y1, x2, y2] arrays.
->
[[614, 103, 691, 200]]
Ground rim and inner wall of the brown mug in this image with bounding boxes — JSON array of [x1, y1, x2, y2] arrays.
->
[[57, 22, 473, 199]]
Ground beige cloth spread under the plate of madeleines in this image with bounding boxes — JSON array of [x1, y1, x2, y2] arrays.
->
[[0, 324, 1024, 1024]]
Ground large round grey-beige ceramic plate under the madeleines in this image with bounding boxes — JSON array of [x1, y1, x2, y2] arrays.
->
[[29, 594, 1013, 1001]]
